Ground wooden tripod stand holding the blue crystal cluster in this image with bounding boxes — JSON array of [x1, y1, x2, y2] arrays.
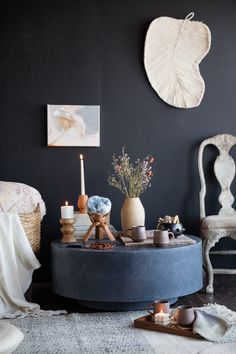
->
[[83, 213, 115, 242]]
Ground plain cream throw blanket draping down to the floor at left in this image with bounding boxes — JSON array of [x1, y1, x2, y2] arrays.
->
[[0, 213, 40, 318]]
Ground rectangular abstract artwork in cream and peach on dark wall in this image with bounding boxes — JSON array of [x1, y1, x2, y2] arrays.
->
[[47, 104, 100, 146]]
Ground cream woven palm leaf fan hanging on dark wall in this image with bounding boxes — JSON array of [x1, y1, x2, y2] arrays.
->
[[144, 12, 211, 108]]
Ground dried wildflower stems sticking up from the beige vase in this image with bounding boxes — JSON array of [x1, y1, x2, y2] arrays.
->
[[107, 146, 154, 198]]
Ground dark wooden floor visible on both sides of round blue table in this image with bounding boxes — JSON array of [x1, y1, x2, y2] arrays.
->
[[31, 275, 236, 312]]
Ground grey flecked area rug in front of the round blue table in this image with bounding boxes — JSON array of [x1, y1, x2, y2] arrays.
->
[[9, 312, 155, 354]]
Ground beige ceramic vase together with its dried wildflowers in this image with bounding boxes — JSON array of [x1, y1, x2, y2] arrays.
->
[[108, 147, 154, 235]]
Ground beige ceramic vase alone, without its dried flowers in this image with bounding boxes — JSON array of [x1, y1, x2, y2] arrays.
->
[[121, 198, 145, 235]]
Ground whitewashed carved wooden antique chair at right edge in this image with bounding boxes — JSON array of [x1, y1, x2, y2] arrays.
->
[[198, 134, 236, 294]]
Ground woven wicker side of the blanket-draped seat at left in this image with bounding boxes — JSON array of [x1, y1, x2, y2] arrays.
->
[[18, 206, 41, 254]]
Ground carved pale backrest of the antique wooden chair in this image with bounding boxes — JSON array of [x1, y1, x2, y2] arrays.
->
[[198, 134, 236, 219]]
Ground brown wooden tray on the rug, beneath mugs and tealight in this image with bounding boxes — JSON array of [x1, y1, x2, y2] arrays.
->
[[134, 315, 203, 339]]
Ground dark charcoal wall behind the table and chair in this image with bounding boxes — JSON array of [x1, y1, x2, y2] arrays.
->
[[0, 0, 236, 279]]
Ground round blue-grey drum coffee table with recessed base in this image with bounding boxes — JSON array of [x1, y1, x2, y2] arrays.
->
[[51, 236, 203, 310]]
